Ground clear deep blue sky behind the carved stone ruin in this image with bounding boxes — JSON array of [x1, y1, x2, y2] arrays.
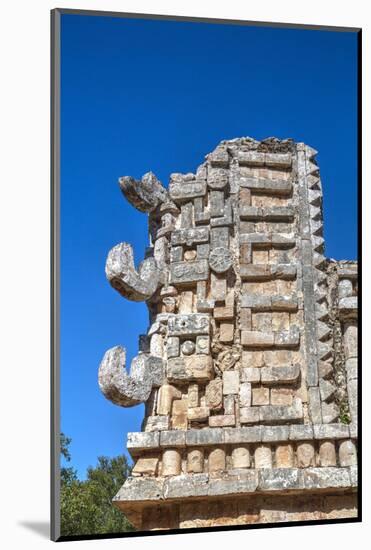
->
[[61, 11, 357, 477]]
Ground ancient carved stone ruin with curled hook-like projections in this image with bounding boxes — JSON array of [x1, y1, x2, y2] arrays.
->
[[99, 138, 357, 530]]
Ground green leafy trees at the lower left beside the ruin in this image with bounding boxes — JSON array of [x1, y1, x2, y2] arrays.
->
[[61, 434, 134, 536]]
